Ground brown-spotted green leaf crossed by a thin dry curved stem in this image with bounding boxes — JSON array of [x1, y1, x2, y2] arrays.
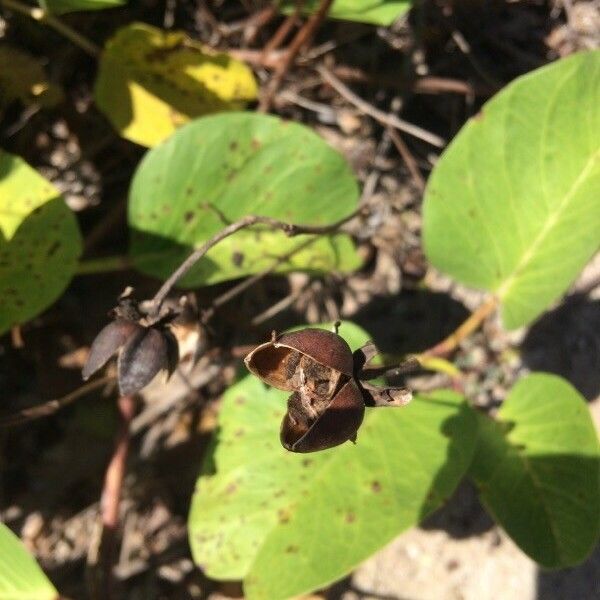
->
[[129, 113, 360, 286]]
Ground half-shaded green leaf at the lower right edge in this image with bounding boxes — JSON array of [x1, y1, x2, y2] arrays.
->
[[470, 374, 600, 568]]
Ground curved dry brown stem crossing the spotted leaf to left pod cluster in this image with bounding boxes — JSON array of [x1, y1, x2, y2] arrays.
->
[[149, 207, 366, 316]]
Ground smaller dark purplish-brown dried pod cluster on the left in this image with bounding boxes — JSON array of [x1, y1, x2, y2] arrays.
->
[[82, 288, 179, 395]]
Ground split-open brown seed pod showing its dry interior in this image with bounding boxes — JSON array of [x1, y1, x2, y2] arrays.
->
[[245, 329, 365, 452]]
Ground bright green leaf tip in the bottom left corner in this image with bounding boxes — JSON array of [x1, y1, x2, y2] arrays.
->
[[0, 523, 59, 600]]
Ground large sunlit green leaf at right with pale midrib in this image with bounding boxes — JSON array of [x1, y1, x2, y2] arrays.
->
[[423, 51, 600, 328]]
